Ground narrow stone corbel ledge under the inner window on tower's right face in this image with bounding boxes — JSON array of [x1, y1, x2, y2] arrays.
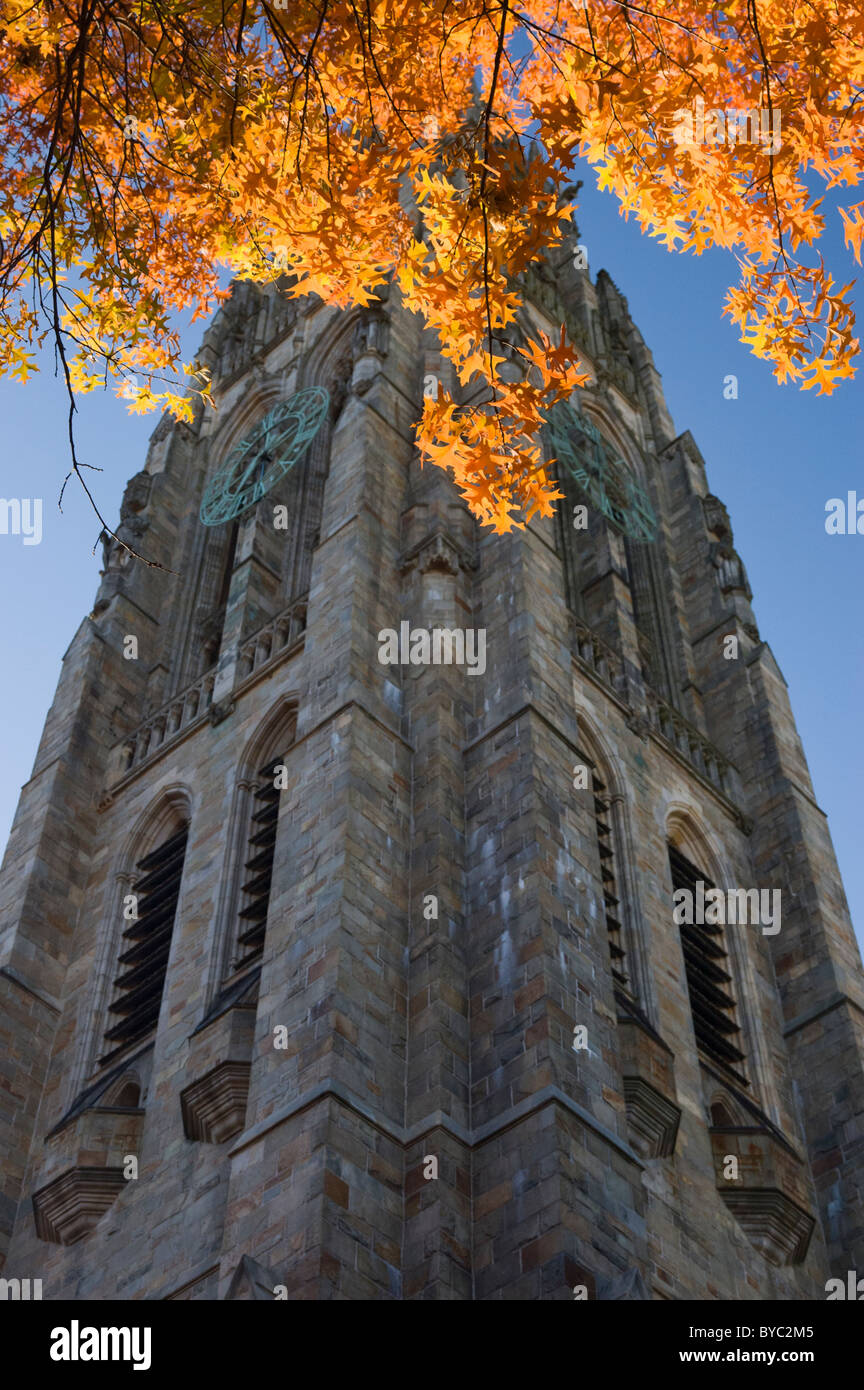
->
[[618, 1016, 681, 1158]]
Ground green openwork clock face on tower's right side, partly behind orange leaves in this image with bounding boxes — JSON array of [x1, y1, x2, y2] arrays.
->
[[546, 402, 657, 541]]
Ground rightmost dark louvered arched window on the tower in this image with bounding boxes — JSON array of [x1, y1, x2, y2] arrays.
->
[[670, 845, 749, 1086]]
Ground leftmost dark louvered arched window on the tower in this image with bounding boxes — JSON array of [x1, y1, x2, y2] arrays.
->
[[99, 824, 189, 1066]]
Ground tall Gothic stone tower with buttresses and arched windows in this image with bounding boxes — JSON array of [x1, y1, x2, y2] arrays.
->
[[0, 231, 864, 1300]]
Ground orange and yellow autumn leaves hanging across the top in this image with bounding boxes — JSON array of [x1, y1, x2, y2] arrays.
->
[[0, 0, 864, 530]]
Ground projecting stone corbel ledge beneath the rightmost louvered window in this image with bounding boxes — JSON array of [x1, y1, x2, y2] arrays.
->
[[711, 1126, 814, 1265]]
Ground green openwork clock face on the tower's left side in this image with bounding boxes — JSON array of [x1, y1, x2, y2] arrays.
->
[[200, 386, 331, 525]]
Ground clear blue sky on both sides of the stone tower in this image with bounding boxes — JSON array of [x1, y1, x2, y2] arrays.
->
[[0, 170, 864, 956]]
